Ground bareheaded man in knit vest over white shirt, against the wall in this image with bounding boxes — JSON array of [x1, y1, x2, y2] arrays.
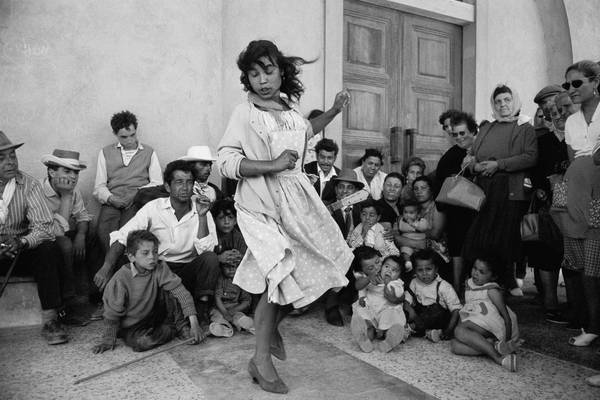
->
[[94, 111, 163, 251]]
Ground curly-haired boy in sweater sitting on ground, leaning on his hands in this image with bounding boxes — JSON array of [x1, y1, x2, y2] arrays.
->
[[93, 230, 206, 353]]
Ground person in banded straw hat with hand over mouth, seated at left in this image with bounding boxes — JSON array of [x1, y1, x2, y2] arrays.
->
[[42, 149, 92, 324]]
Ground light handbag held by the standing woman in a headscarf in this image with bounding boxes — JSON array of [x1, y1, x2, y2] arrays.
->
[[435, 165, 485, 211]]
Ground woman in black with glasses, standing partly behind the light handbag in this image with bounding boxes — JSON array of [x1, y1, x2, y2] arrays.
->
[[435, 111, 477, 293]]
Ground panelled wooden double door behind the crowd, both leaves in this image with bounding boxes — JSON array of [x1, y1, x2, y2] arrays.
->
[[342, 0, 462, 171]]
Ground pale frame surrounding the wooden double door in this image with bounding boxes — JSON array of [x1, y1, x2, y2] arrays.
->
[[323, 0, 476, 166]]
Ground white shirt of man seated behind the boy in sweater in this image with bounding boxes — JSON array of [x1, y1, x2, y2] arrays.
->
[[110, 197, 218, 263]]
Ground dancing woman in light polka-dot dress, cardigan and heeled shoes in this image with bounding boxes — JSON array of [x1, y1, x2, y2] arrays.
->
[[217, 40, 353, 393]]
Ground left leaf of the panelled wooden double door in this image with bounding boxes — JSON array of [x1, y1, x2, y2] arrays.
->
[[342, 1, 398, 168]]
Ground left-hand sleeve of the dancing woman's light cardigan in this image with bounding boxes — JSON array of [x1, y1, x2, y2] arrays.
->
[[216, 106, 246, 180]]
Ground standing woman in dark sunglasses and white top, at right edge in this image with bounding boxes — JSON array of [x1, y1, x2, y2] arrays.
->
[[562, 60, 600, 346]]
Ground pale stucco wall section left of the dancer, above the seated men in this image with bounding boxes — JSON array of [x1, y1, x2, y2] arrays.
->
[[0, 0, 223, 219]]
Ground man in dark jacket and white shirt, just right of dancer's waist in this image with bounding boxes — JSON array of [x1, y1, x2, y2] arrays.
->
[[304, 139, 340, 204]]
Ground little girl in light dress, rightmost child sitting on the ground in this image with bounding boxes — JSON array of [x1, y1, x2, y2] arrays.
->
[[451, 256, 519, 372]]
